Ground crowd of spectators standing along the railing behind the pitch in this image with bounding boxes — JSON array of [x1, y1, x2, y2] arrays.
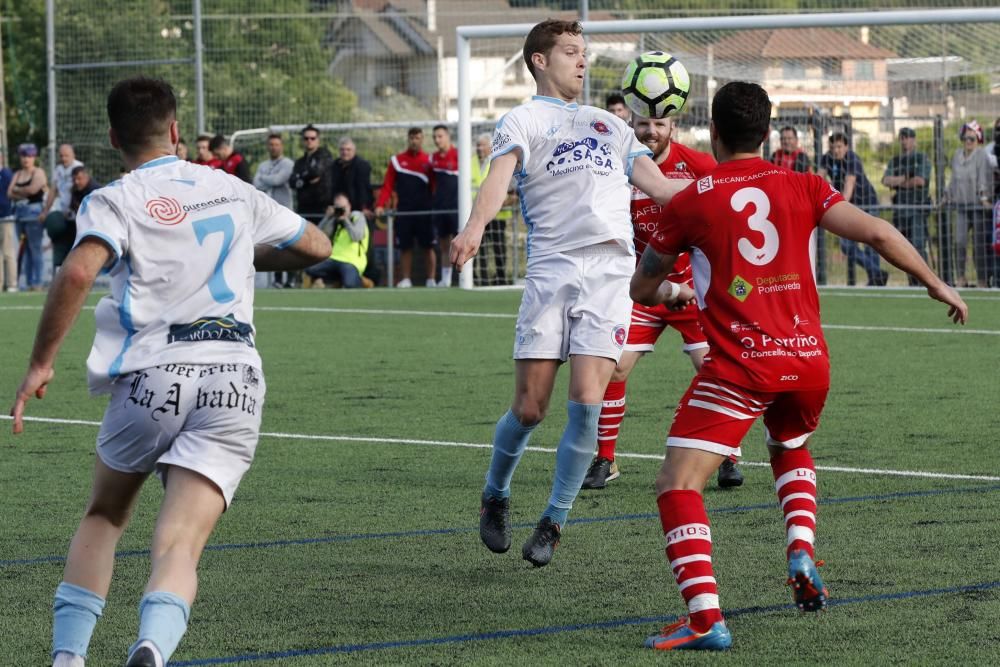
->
[[0, 116, 1000, 292]]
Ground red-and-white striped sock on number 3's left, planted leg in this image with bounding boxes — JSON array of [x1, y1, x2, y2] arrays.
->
[[656, 491, 722, 632]]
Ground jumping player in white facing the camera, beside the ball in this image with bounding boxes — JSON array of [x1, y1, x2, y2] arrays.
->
[[451, 20, 686, 567]]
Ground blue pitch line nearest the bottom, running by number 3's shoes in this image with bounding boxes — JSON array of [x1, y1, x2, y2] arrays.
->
[[169, 581, 1000, 667]]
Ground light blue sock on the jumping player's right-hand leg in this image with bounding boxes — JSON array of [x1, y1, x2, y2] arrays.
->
[[542, 401, 601, 526]]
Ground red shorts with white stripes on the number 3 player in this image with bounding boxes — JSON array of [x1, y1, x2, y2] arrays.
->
[[667, 373, 829, 456]]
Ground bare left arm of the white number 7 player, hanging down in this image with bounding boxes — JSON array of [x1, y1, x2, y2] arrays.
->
[[10, 236, 114, 433]]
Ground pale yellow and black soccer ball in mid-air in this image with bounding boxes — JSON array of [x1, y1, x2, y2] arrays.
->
[[622, 51, 691, 118]]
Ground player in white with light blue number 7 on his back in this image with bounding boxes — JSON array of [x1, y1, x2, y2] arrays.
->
[[11, 77, 330, 667]]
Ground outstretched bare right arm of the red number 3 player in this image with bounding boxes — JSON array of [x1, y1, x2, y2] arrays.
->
[[820, 201, 969, 324]]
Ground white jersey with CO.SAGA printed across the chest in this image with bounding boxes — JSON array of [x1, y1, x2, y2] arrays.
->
[[490, 95, 652, 258]]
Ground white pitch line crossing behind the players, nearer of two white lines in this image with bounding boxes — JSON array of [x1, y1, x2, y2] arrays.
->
[[0, 415, 1000, 482]]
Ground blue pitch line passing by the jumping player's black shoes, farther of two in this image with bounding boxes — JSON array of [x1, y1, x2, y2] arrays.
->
[[0, 484, 1000, 568]]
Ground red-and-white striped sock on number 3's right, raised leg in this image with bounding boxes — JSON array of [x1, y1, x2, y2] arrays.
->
[[771, 447, 816, 558]]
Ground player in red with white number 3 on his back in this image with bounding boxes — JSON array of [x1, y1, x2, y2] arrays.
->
[[631, 82, 968, 650]]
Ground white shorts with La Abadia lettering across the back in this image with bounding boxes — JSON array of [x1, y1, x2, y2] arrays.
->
[[97, 364, 266, 507]]
